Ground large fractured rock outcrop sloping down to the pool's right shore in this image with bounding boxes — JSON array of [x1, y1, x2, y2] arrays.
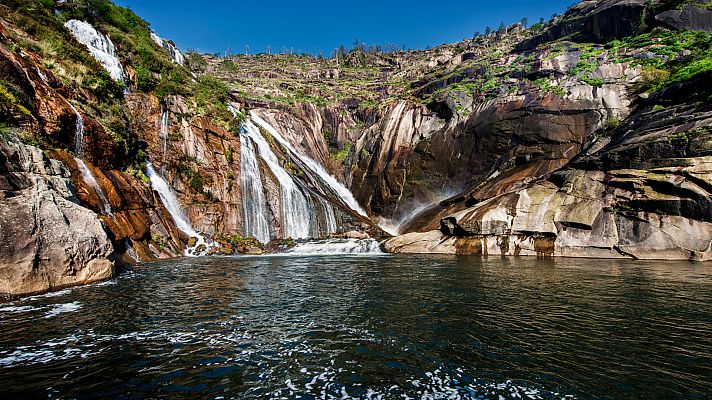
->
[[386, 76, 712, 261]]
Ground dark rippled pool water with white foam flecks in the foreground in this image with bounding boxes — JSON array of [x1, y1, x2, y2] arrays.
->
[[0, 256, 712, 399]]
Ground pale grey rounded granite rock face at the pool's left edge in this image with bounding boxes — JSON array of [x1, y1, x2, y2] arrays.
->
[[0, 139, 114, 296]]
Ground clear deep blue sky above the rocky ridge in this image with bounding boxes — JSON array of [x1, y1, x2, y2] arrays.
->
[[115, 0, 574, 55]]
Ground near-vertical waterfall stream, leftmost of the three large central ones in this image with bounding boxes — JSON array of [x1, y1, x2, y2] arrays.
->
[[240, 126, 271, 243]]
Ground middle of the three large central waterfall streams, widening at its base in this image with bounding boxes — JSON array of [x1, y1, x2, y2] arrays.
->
[[242, 121, 315, 239]]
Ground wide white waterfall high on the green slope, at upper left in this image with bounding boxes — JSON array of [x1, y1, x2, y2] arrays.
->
[[64, 19, 124, 82]]
